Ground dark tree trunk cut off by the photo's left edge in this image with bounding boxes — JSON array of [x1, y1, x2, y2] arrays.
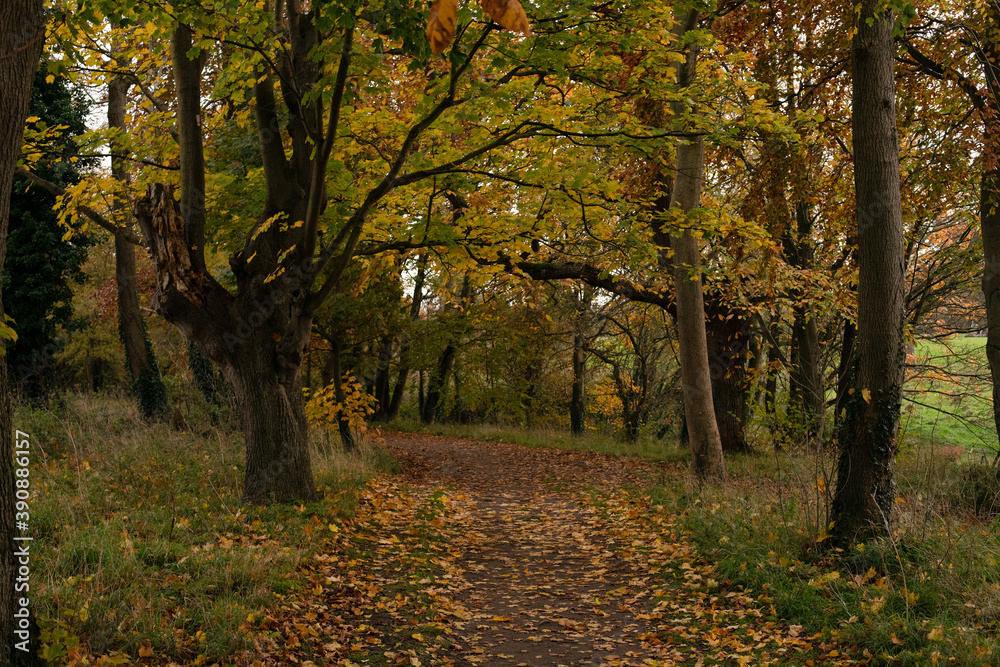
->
[[0, 0, 45, 665]]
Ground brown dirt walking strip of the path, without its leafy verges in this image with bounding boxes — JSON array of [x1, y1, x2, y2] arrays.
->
[[390, 435, 664, 665]]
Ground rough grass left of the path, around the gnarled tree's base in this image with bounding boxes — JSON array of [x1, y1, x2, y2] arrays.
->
[[15, 388, 393, 664]]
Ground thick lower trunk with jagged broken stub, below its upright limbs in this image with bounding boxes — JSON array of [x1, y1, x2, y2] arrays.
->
[[136, 185, 318, 504]]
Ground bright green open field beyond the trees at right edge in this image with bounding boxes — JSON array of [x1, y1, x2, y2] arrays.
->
[[901, 336, 997, 451]]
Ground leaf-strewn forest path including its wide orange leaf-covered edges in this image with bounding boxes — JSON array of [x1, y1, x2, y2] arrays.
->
[[262, 433, 860, 667]]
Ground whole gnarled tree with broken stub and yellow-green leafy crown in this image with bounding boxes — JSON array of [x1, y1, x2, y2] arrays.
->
[[117, 1, 543, 503]]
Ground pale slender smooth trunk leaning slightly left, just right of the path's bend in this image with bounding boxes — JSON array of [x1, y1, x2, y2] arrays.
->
[[670, 10, 726, 482]]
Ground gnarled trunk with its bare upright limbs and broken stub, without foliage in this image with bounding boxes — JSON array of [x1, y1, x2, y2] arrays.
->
[[135, 18, 324, 503]]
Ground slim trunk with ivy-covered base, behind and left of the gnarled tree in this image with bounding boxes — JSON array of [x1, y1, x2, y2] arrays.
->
[[108, 78, 170, 421]]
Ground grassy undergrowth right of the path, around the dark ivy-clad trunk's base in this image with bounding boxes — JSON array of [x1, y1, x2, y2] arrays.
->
[[647, 447, 1000, 665]]
